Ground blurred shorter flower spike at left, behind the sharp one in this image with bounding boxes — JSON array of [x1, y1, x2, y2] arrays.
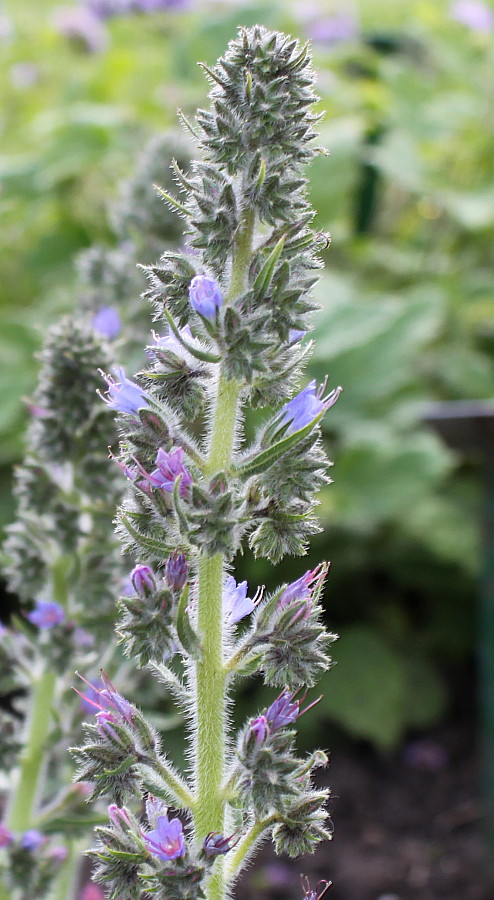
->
[[0, 316, 123, 900]]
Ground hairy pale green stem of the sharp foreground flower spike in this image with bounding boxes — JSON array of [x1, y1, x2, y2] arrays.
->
[[193, 212, 254, 900]]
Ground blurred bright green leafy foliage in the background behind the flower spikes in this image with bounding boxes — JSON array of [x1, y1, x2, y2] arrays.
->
[[0, 0, 494, 749]]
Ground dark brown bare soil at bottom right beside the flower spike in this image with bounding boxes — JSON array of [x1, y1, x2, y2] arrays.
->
[[237, 724, 494, 900]]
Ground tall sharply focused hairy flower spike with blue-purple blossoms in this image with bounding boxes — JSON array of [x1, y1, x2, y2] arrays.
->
[[74, 27, 339, 900]]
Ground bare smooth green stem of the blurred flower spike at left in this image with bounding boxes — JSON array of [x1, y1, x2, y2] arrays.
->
[[6, 671, 56, 831]]
